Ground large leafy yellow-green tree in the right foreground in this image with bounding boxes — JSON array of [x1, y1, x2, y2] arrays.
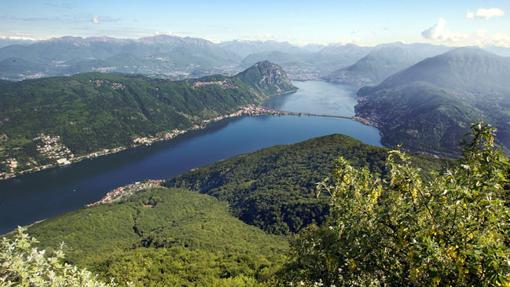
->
[[283, 123, 510, 286]]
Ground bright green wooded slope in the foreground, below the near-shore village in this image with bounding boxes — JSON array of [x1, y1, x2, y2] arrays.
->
[[28, 188, 287, 286]]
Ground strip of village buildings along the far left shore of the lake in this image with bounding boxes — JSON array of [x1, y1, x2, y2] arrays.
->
[[0, 105, 282, 180]]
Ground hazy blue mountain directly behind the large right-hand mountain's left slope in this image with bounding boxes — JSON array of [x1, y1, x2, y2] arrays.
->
[[325, 43, 448, 88]]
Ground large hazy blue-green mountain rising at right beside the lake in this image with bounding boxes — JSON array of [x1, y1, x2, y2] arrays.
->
[[356, 47, 510, 154]]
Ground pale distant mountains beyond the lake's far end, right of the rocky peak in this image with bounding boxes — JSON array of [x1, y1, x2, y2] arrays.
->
[[241, 44, 370, 80]]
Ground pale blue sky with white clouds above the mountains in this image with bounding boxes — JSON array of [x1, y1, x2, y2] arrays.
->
[[0, 0, 510, 47]]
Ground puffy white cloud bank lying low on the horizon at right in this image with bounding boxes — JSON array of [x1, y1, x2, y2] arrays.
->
[[421, 18, 510, 47]]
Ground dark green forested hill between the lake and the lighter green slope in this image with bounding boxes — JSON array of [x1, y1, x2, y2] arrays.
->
[[166, 135, 438, 234]]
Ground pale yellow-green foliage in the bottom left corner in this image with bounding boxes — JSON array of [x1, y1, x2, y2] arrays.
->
[[0, 228, 115, 287]]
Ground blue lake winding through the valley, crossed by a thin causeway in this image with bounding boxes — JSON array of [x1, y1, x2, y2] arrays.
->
[[0, 82, 380, 234]]
